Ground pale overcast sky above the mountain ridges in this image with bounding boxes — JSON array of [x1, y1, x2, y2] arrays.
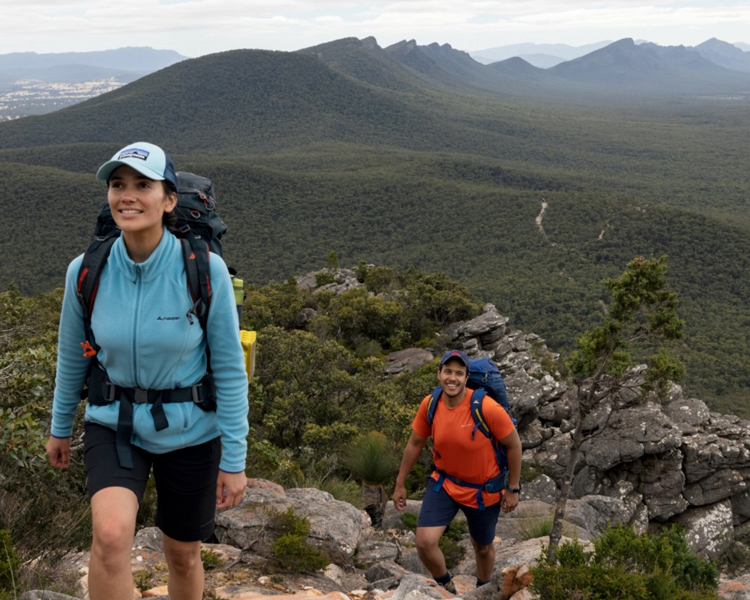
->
[[0, 0, 750, 57]]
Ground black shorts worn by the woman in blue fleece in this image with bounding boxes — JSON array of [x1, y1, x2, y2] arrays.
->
[[83, 423, 221, 542]]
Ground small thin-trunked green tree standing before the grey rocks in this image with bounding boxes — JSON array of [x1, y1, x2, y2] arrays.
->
[[548, 256, 684, 561]]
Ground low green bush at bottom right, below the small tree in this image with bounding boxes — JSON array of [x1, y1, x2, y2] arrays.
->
[[530, 526, 718, 600]]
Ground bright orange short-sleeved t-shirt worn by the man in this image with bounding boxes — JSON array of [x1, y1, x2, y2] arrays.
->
[[418, 388, 514, 508]]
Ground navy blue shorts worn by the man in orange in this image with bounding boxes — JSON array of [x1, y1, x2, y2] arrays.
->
[[417, 477, 500, 546]]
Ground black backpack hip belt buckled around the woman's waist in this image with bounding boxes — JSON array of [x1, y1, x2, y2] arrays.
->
[[88, 363, 216, 469]]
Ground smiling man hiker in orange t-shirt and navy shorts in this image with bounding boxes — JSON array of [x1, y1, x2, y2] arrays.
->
[[393, 350, 522, 593]]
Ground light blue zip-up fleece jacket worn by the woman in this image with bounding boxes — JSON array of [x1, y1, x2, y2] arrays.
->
[[51, 230, 248, 473]]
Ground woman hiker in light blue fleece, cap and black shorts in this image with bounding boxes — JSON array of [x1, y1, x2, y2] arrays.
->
[[47, 142, 248, 600]]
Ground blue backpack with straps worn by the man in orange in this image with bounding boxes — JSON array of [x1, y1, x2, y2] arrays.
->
[[427, 358, 517, 510]]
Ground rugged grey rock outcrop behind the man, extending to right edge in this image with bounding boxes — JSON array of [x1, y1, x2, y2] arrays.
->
[[388, 304, 750, 557]]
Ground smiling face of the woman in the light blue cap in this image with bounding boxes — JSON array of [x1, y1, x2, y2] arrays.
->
[[107, 165, 177, 236]]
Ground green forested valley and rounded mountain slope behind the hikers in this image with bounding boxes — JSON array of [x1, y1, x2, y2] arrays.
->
[[0, 38, 750, 415]]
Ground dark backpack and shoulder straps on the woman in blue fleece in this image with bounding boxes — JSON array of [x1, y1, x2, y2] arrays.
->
[[78, 172, 227, 356]]
